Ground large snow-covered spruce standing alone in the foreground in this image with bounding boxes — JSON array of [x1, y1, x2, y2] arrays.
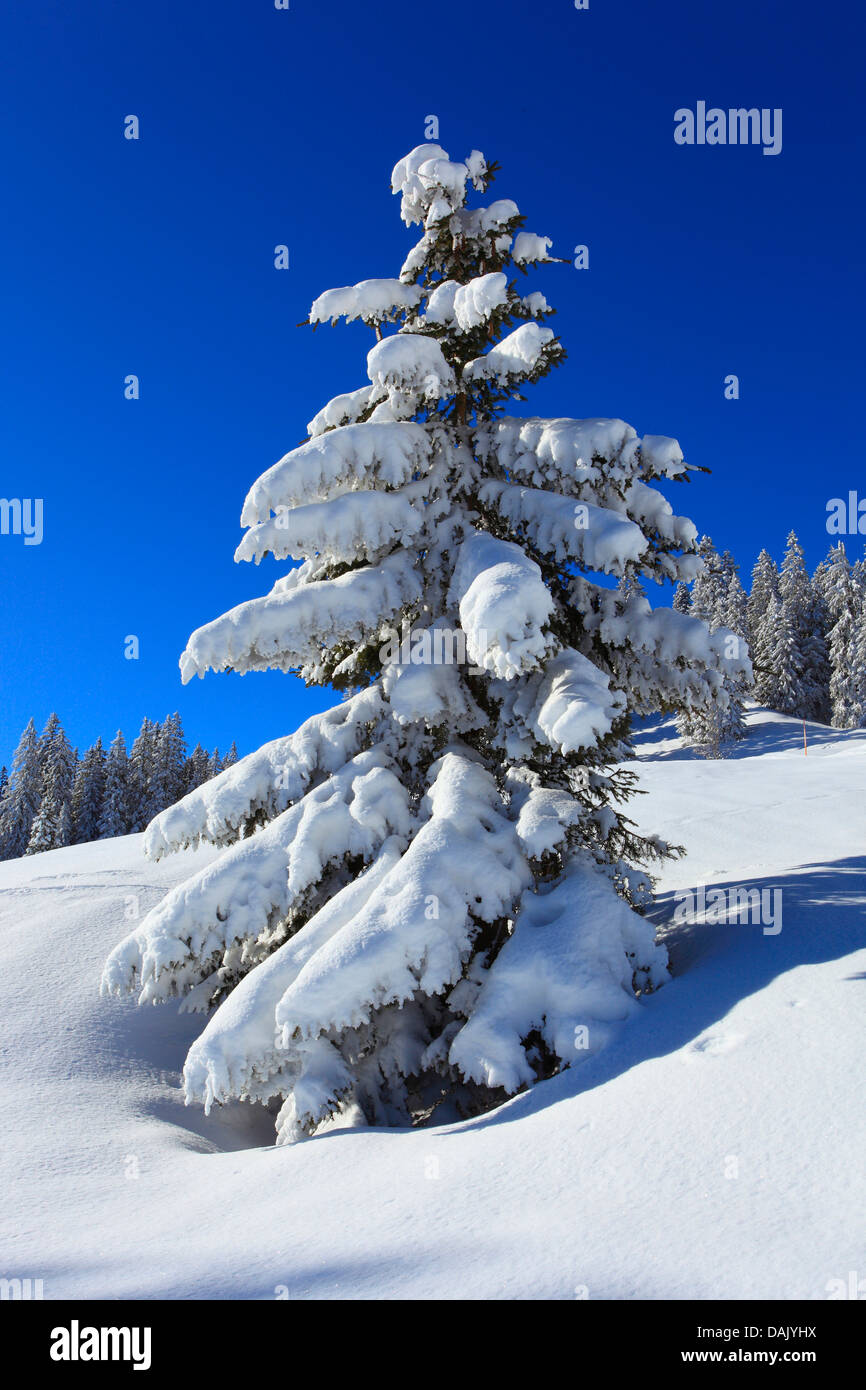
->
[[103, 145, 748, 1141]]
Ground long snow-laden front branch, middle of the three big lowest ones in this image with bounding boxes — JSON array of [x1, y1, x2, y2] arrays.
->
[[185, 752, 531, 1138]]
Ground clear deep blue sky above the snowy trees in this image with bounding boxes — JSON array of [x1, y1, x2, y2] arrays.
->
[[0, 0, 866, 762]]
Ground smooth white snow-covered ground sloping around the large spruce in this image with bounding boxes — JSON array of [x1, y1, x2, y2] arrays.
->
[[0, 710, 866, 1298]]
